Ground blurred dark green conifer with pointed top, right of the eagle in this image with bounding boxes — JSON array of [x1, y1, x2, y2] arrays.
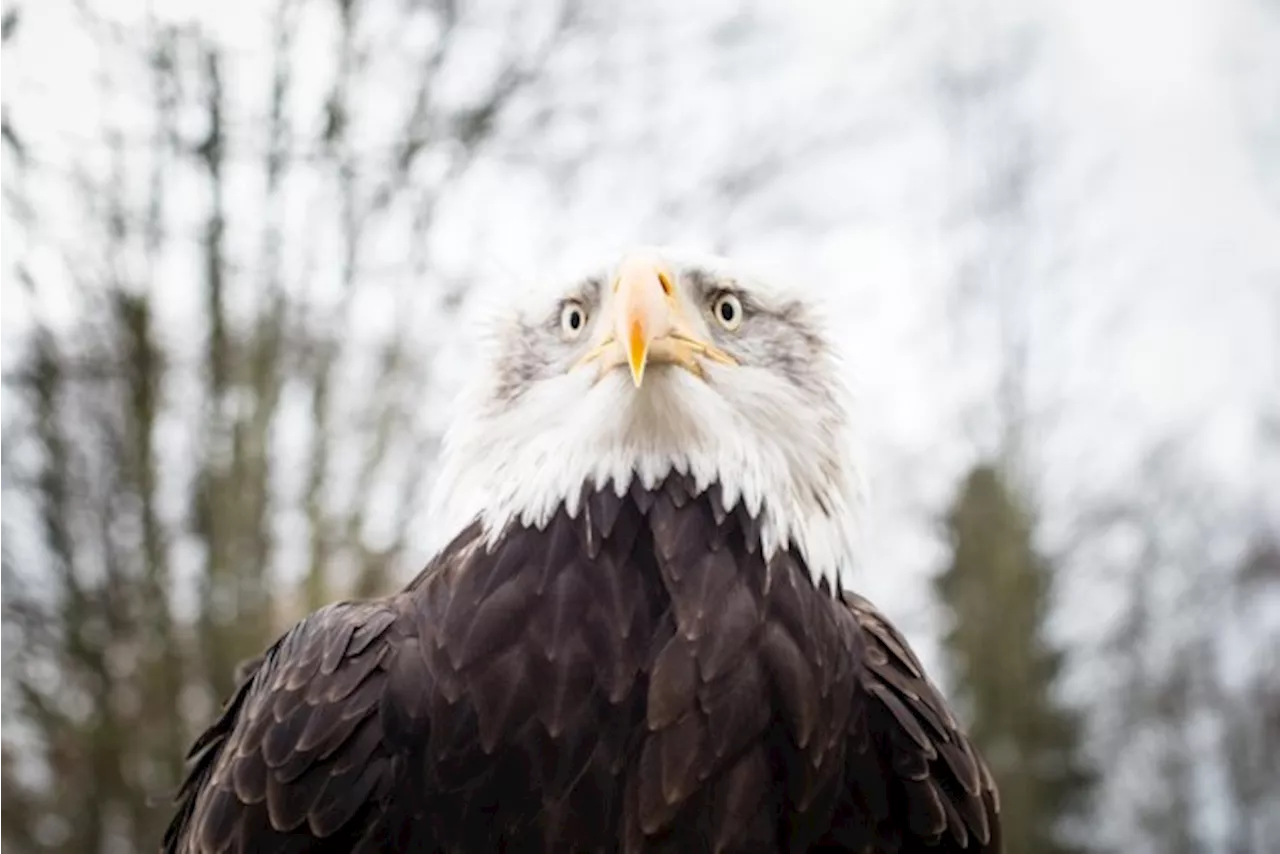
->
[[936, 462, 1093, 854]]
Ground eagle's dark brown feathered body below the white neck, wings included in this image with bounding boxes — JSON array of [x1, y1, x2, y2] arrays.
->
[[163, 476, 1000, 854]]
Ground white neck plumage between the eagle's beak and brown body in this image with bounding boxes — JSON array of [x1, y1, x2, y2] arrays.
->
[[430, 370, 863, 585]]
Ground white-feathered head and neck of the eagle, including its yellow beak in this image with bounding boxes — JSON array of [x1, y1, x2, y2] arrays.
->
[[430, 243, 863, 581]]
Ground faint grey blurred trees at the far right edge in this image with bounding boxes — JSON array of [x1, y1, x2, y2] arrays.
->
[[1076, 443, 1280, 854]]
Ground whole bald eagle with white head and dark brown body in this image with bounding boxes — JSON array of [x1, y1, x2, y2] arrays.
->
[[163, 251, 1000, 854]]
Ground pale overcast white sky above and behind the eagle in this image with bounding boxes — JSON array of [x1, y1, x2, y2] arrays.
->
[[0, 0, 1280, 637]]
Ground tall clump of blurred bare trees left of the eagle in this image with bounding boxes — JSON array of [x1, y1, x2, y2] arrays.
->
[[0, 0, 581, 854]]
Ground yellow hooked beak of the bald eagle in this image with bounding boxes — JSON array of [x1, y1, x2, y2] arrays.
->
[[582, 257, 737, 388]]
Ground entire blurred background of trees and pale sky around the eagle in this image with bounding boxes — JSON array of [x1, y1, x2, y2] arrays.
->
[[0, 0, 1280, 854]]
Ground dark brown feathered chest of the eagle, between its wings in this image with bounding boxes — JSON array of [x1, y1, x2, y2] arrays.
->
[[426, 481, 852, 850]]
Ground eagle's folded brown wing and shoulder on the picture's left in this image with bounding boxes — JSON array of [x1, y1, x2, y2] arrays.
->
[[161, 594, 430, 854]]
